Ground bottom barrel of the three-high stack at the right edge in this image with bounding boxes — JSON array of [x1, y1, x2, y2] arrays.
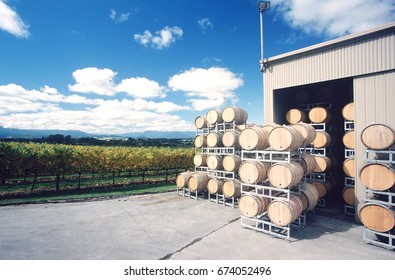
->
[[357, 200, 395, 232]]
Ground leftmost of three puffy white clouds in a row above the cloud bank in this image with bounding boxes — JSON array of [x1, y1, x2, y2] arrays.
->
[[69, 67, 117, 96]]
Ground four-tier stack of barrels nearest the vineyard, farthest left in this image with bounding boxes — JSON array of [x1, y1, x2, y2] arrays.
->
[[176, 106, 248, 198]]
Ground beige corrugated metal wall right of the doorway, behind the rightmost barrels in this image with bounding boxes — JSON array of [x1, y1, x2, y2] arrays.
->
[[354, 71, 395, 208]]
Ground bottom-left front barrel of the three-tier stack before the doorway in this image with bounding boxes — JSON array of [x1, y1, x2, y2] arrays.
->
[[238, 193, 269, 218]]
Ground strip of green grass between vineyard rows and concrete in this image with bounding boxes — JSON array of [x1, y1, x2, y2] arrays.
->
[[0, 183, 176, 206]]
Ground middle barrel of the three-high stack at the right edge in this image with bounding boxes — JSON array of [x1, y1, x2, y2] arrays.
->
[[359, 163, 395, 191]]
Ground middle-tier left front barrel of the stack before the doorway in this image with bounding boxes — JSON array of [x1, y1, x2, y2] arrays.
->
[[239, 161, 270, 184]]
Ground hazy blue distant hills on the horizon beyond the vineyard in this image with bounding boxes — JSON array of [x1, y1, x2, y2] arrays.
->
[[0, 126, 195, 139]]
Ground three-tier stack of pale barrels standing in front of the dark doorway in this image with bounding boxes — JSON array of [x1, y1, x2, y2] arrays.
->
[[238, 123, 319, 226]]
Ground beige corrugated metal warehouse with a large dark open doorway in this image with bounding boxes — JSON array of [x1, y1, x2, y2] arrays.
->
[[263, 22, 395, 220]]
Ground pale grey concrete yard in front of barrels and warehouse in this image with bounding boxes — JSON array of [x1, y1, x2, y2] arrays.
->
[[0, 192, 395, 260]]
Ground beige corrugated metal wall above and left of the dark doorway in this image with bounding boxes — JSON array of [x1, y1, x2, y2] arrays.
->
[[264, 24, 395, 123]]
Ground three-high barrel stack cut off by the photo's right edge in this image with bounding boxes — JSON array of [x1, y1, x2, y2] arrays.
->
[[357, 124, 395, 249]]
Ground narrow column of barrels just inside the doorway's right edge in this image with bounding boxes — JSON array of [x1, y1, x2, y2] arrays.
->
[[342, 102, 356, 209]]
